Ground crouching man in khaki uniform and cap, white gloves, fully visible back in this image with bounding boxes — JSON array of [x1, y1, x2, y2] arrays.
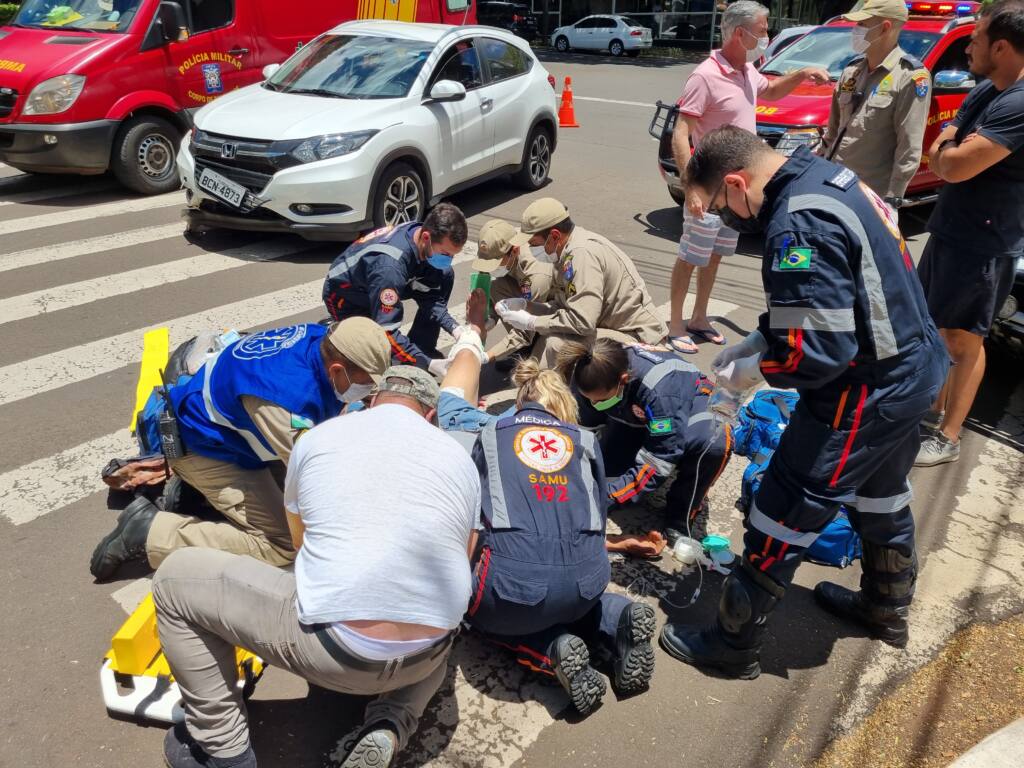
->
[[495, 198, 665, 368]]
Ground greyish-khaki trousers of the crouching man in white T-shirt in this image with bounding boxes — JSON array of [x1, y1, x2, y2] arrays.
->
[[153, 547, 451, 758]]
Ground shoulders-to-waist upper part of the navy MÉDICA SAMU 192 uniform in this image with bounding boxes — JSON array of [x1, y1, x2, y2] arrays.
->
[[475, 403, 608, 569]]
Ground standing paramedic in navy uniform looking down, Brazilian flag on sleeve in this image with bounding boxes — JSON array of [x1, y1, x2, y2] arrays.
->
[[662, 127, 948, 679]]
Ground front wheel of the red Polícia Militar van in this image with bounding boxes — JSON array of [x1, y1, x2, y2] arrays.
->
[[111, 116, 181, 195]]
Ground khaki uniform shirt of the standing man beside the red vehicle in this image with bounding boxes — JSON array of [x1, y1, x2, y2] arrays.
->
[[823, 46, 932, 198]]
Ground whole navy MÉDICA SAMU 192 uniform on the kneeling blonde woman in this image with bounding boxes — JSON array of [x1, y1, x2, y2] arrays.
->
[[467, 403, 631, 674]]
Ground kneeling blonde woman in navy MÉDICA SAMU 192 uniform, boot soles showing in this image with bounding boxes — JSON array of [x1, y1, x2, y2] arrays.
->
[[467, 393, 654, 715]]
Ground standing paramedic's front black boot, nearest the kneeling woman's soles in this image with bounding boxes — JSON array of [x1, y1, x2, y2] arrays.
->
[[660, 560, 785, 680]]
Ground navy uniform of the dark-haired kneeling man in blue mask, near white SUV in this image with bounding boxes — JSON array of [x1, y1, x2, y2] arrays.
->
[[324, 222, 459, 368]]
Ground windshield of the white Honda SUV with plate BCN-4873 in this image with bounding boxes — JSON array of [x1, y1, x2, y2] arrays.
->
[[263, 35, 434, 98]]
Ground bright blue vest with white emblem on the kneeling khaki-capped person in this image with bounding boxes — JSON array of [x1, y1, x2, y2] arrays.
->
[[170, 324, 342, 469]]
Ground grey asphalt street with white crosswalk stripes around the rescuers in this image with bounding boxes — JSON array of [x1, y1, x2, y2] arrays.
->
[[0, 55, 1024, 768]]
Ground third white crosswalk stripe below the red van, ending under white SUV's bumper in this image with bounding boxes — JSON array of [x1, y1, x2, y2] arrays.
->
[[0, 240, 311, 325]]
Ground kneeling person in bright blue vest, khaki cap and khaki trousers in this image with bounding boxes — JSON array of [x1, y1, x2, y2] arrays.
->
[[90, 317, 391, 580]]
